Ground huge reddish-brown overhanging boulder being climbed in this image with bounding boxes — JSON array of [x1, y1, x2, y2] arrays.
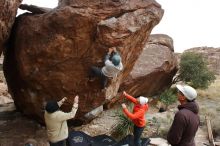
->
[[3, 0, 163, 122]]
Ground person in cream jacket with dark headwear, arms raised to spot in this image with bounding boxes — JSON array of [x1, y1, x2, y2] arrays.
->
[[44, 96, 79, 146]]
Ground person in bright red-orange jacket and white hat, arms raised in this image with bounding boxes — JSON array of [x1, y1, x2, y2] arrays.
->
[[122, 91, 148, 146]]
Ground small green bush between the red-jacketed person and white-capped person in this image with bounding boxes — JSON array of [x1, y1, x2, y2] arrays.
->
[[159, 88, 177, 110]]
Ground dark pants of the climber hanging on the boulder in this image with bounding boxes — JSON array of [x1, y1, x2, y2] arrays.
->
[[89, 66, 108, 89]]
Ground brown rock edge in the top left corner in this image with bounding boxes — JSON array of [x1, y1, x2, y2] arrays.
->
[[0, 0, 22, 55]]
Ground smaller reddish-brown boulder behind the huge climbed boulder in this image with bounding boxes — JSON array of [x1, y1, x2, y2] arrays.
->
[[120, 34, 177, 96]]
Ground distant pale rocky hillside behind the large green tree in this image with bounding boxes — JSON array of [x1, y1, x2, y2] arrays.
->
[[184, 47, 220, 75]]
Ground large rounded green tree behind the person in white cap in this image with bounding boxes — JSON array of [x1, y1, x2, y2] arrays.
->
[[174, 52, 215, 89]]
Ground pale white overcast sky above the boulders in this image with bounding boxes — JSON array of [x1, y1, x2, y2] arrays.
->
[[19, 0, 220, 53]]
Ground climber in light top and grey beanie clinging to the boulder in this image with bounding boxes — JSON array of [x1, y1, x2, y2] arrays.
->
[[89, 47, 123, 89]]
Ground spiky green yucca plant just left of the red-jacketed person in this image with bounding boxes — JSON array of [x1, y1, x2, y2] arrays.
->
[[111, 106, 134, 140]]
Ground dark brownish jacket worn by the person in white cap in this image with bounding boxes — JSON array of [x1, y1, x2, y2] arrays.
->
[[167, 102, 199, 146]]
